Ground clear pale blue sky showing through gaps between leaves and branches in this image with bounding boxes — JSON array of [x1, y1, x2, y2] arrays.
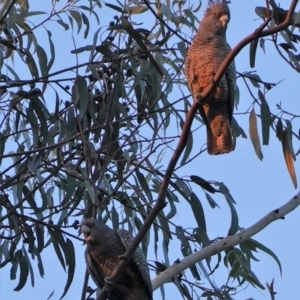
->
[[0, 0, 300, 300]]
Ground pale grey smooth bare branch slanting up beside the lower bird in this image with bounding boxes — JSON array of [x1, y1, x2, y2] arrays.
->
[[152, 192, 300, 290]]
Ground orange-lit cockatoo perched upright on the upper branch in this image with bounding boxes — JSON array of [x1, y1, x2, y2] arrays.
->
[[185, 0, 236, 155]]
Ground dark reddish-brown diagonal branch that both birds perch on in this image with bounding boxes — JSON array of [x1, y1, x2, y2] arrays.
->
[[97, 0, 298, 300]]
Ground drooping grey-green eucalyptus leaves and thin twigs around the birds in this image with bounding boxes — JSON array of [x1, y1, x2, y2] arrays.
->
[[0, 0, 300, 299]]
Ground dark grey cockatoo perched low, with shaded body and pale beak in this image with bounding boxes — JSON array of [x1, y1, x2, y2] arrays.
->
[[81, 219, 153, 300]]
